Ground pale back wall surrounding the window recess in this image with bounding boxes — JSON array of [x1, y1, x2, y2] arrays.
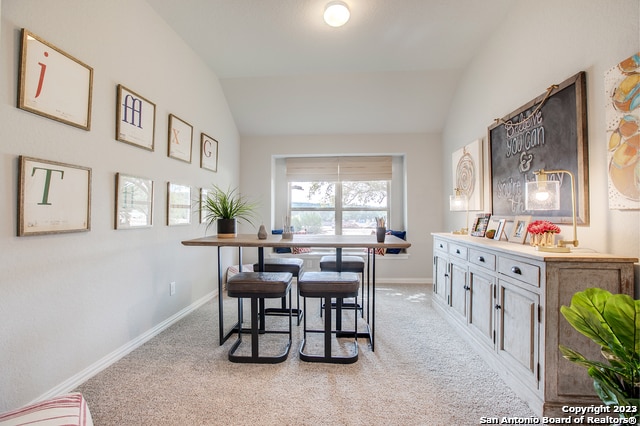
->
[[240, 134, 442, 282]]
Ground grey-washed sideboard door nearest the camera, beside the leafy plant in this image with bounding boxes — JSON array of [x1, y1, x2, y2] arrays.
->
[[495, 280, 540, 389]]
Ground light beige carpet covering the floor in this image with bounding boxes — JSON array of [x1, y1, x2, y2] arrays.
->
[[77, 285, 533, 426]]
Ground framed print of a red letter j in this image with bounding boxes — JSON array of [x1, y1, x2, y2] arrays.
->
[[18, 28, 93, 130]]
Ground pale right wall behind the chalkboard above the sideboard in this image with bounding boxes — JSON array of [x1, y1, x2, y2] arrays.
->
[[442, 0, 640, 289]]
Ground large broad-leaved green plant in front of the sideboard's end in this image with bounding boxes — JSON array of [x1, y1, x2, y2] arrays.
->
[[560, 288, 640, 418]]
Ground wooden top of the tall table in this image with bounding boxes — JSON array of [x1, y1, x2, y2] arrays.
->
[[182, 234, 411, 248]]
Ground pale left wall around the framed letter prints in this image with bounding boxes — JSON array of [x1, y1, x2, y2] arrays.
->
[[0, 0, 239, 411]]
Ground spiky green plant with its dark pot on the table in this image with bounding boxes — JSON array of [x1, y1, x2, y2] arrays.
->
[[201, 185, 258, 238]]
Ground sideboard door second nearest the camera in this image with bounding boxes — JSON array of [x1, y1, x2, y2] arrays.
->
[[468, 268, 496, 349]]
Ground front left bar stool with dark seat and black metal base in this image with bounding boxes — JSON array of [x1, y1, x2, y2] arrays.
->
[[227, 272, 292, 364]]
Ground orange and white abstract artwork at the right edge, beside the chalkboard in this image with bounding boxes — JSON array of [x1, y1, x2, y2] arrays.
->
[[604, 53, 640, 209]]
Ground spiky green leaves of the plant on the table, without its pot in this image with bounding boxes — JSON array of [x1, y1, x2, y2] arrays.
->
[[202, 185, 258, 229]]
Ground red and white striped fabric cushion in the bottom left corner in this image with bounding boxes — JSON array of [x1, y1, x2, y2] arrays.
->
[[0, 393, 93, 426]]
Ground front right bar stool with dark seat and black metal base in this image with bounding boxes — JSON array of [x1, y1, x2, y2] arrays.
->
[[298, 271, 360, 364]]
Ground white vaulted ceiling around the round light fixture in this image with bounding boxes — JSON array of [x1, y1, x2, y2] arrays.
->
[[147, 0, 512, 135]]
